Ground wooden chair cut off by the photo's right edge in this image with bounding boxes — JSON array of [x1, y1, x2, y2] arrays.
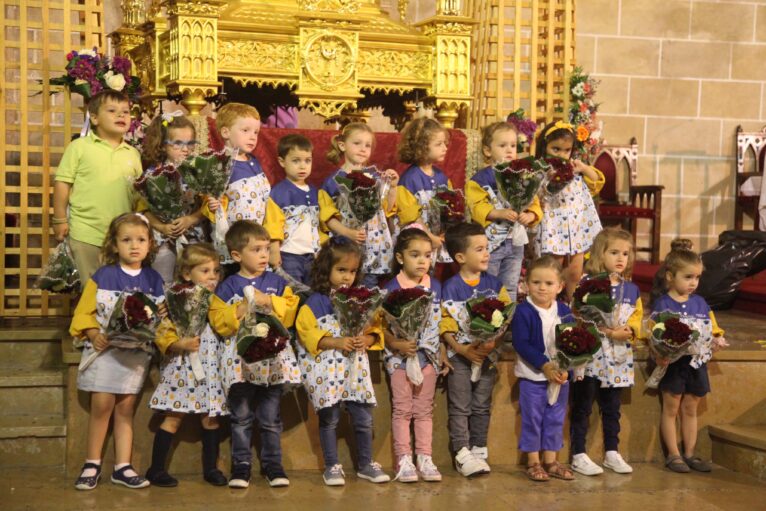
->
[[734, 126, 766, 231]]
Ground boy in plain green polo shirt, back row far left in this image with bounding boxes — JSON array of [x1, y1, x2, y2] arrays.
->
[[51, 89, 142, 283]]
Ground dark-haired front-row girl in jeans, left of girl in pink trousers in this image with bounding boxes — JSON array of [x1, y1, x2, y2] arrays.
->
[[295, 236, 390, 486]]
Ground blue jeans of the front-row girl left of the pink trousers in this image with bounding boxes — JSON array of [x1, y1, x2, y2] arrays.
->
[[317, 401, 372, 470]]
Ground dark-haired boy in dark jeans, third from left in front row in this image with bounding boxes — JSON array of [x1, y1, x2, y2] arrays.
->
[[209, 220, 301, 488]]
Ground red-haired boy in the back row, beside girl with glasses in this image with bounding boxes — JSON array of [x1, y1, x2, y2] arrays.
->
[[206, 103, 271, 268]]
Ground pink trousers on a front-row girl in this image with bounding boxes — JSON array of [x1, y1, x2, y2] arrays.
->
[[391, 364, 436, 458]]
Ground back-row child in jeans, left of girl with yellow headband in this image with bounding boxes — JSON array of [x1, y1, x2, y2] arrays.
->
[[465, 122, 543, 302]]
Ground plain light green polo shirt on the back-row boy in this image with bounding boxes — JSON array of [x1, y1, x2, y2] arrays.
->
[[56, 132, 142, 246]]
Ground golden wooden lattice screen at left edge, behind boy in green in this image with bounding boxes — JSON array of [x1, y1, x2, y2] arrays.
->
[[0, 0, 104, 317]]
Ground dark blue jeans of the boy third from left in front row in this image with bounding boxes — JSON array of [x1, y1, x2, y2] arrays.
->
[[229, 383, 282, 472]]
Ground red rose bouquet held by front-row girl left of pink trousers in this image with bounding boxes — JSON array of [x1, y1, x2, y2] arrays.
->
[[330, 286, 385, 382]]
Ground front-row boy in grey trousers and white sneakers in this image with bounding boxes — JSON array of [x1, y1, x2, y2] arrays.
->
[[440, 223, 510, 477]]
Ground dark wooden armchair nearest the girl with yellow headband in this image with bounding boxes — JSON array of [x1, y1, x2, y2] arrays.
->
[[593, 137, 665, 264]]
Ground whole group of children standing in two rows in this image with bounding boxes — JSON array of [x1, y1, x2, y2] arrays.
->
[[57, 91, 722, 490]]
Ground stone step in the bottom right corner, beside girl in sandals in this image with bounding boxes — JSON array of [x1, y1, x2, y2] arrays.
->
[[708, 424, 766, 480]]
